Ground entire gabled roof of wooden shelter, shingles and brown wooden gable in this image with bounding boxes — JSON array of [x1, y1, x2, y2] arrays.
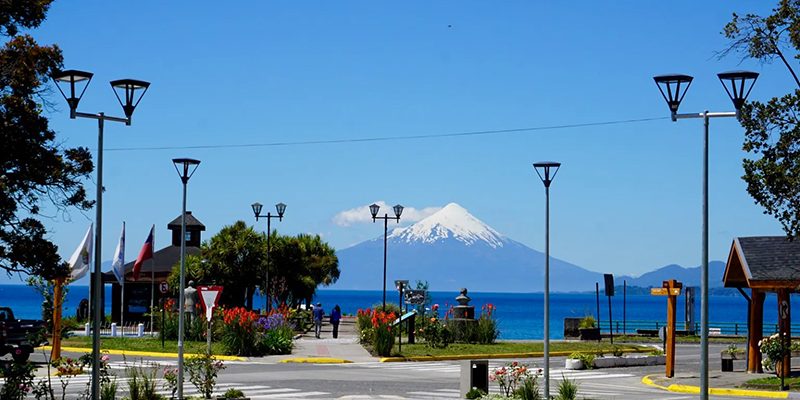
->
[[722, 236, 800, 291]]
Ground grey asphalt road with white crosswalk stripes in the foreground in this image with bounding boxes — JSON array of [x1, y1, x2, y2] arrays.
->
[[15, 345, 772, 400]]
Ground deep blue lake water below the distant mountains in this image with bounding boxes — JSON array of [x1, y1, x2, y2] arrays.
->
[[0, 285, 800, 339]]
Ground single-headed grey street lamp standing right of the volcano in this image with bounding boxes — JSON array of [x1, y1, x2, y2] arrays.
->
[[533, 161, 561, 398]]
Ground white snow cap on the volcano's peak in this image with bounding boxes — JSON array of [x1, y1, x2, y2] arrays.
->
[[389, 203, 508, 248]]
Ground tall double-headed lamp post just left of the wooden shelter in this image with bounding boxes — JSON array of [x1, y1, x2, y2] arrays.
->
[[653, 71, 758, 400]]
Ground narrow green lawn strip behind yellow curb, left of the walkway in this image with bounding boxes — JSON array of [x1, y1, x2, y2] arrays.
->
[[61, 336, 224, 354]]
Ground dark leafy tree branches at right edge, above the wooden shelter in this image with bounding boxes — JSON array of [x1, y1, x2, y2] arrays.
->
[[722, 0, 800, 238]]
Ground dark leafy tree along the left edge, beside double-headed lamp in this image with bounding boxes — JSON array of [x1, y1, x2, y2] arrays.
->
[[0, 0, 93, 279]]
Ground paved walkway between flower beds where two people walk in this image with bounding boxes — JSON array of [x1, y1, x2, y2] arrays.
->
[[264, 317, 378, 363]]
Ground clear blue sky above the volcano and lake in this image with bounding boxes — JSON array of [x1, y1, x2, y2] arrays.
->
[[0, 0, 793, 279]]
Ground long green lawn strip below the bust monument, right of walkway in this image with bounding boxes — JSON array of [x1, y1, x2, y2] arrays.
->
[[393, 341, 649, 357]]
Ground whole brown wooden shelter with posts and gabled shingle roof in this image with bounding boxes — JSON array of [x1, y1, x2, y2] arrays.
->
[[722, 236, 800, 376]]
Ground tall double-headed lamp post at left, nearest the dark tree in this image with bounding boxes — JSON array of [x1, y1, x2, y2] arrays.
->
[[52, 69, 150, 399]]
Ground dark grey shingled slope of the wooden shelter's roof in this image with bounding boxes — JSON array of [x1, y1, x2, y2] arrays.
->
[[736, 236, 800, 281]]
